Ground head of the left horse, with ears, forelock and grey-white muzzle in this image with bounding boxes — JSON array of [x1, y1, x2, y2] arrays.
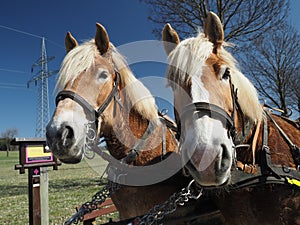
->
[[46, 23, 120, 163]]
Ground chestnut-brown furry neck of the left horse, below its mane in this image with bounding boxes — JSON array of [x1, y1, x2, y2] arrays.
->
[[103, 100, 178, 165]]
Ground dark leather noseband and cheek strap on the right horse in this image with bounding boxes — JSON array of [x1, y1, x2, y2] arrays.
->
[[179, 69, 244, 140]]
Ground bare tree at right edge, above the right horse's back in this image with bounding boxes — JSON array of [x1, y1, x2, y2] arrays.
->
[[242, 23, 300, 117]]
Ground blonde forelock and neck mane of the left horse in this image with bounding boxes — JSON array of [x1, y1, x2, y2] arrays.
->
[[55, 39, 158, 120]]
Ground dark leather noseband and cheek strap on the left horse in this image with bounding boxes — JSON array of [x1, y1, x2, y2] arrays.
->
[[55, 69, 120, 127]]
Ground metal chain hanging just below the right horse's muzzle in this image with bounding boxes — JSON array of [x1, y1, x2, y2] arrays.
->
[[134, 180, 203, 225]]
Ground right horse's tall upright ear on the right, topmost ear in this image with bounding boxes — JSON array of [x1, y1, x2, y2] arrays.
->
[[204, 12, 224, 53]]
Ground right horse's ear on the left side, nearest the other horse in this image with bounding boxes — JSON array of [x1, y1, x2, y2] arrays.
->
[[162, 23, 180, 55]]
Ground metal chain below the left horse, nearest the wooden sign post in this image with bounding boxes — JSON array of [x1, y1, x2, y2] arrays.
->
[[63, 182, 120, 225]]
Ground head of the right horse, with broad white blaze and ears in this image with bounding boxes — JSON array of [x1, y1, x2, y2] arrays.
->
[[163, 12, 261, 187]]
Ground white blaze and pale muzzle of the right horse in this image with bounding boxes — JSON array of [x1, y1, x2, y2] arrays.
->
[[181, 76, 232, 186]]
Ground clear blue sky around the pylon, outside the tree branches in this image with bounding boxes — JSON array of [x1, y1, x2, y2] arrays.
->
[[0, 0, 300, 137]]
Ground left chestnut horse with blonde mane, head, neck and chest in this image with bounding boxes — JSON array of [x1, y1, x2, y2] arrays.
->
[[46, 23, 197, 219]]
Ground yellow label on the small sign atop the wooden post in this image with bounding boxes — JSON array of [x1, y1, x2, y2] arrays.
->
[[26, 145, 53, 163]]
